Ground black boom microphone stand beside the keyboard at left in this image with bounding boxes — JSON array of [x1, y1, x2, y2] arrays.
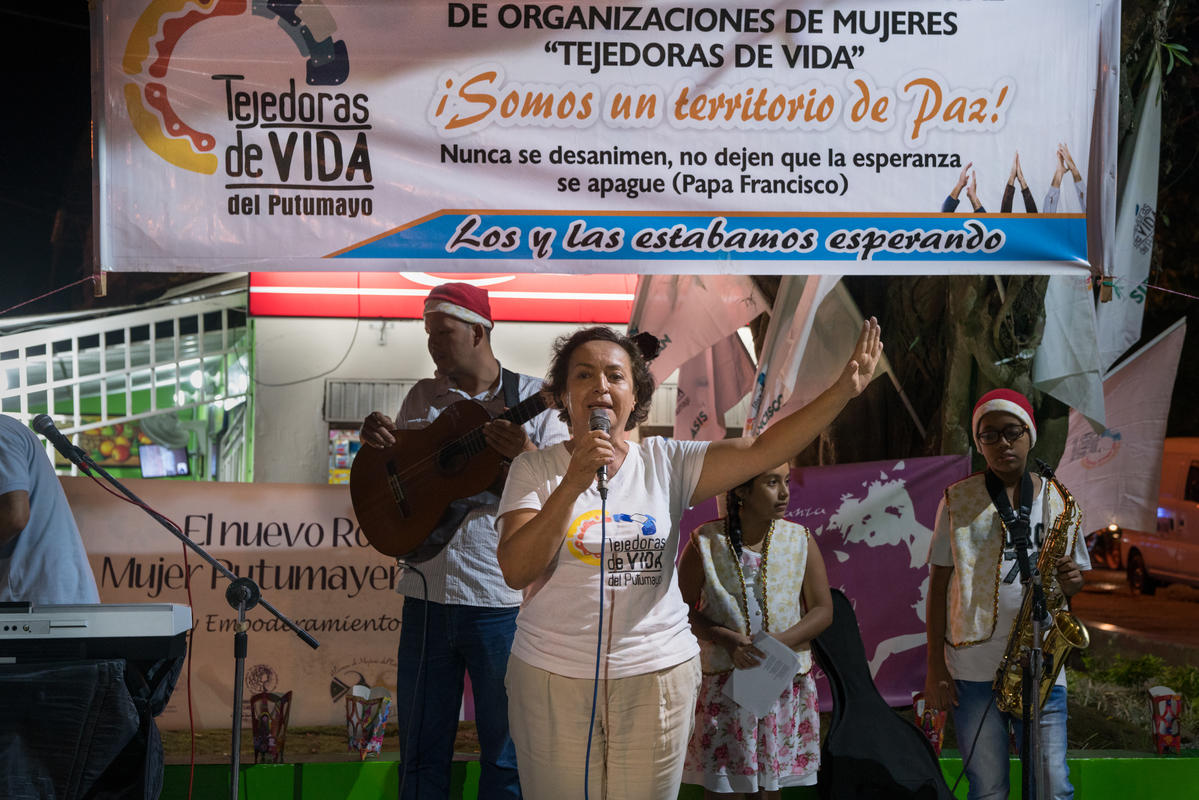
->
[[50, 427, 320, 800]]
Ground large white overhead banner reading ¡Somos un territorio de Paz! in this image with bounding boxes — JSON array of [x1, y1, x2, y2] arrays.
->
[[92, 0, 1114, 275]]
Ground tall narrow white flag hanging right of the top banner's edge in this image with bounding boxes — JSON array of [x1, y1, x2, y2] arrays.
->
[[1096, 64, 1162, 369]]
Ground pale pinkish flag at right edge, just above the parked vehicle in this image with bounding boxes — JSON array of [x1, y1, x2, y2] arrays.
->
[[1058, 319, 1187, 531]]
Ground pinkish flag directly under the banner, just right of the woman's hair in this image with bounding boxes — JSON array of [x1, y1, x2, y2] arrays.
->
[[628, 275, 770, 384]]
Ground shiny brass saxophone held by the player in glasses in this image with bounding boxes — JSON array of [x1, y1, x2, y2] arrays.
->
[[993, 477, 1091, 717]]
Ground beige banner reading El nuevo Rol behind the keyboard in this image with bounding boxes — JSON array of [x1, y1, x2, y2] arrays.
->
[[62, 477, 404, 729]]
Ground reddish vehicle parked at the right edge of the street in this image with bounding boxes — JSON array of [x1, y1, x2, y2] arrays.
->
[[1109, 437, 1199, 595]]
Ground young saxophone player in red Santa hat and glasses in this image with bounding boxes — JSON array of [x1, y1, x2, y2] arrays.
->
[[924, 389, 1091, 800]]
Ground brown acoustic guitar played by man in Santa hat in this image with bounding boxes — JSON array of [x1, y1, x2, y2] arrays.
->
[[350, 393, 548, 563]]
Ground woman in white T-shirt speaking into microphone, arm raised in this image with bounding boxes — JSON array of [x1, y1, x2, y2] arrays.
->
[[499, 318, 882, 800]]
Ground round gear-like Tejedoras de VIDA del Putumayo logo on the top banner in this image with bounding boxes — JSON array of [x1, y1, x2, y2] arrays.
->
[[121, 0, 374, 216]]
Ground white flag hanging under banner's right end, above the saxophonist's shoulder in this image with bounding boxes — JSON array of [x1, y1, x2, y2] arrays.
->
[[1032, 275, 1103, 428]]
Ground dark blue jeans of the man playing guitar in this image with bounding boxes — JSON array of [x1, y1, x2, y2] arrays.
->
[[396, 597, 520, 800]]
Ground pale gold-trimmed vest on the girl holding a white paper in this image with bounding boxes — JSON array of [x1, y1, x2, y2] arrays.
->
[[692, 519, 812, 675]]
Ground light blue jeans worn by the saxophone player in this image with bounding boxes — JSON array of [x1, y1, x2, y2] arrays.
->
[[953, 680, 1074, 800]]
